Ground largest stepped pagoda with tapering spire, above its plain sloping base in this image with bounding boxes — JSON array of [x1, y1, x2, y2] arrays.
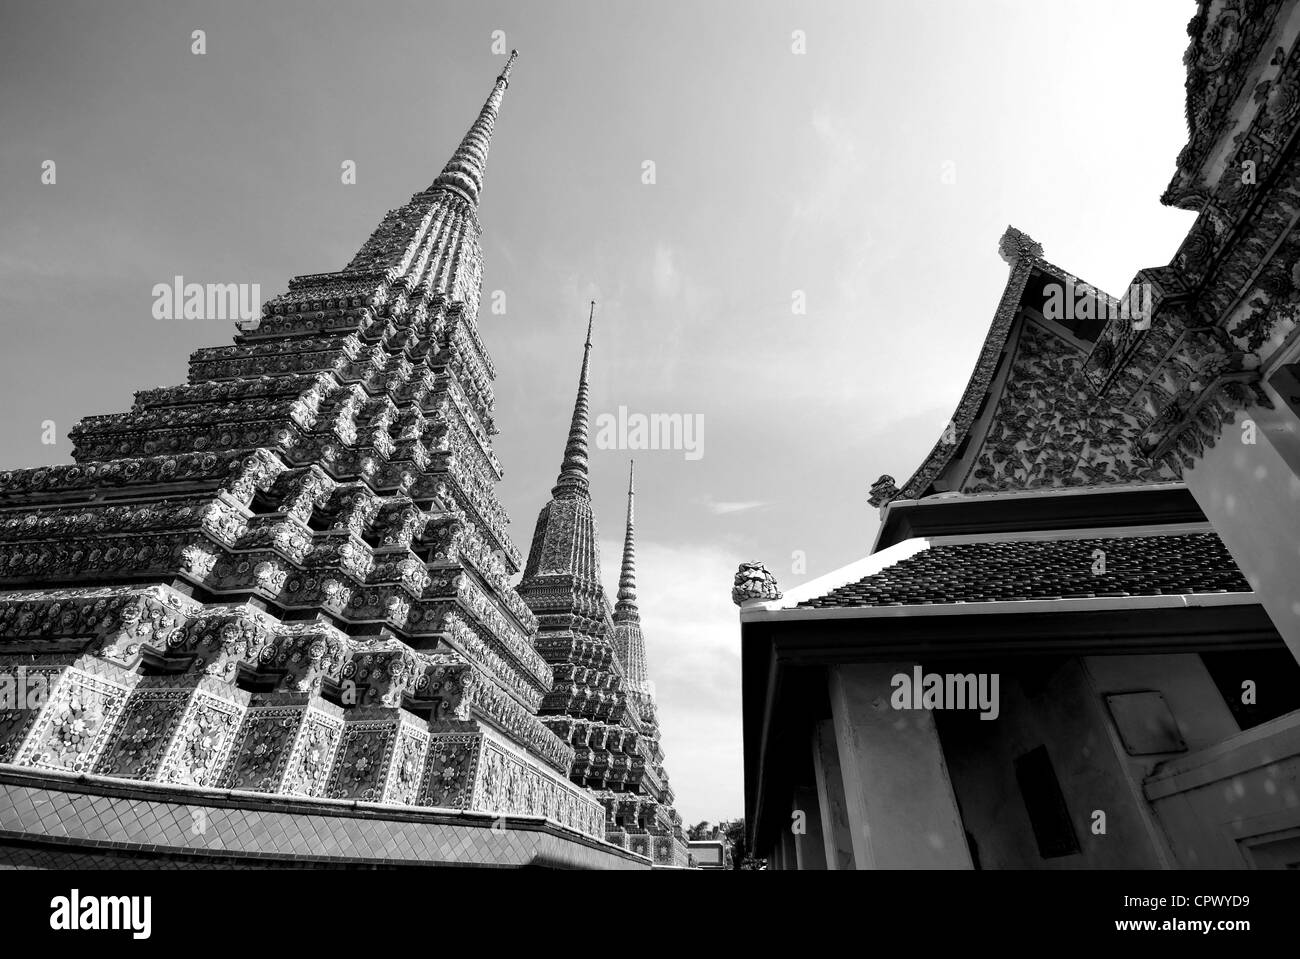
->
[[0, 53, 616, 857]]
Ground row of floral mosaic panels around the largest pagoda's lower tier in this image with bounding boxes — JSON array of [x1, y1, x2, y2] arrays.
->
[[0, 656, 605, 838]]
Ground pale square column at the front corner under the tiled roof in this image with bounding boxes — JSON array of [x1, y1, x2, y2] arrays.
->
[[831, 663, 972, 869]]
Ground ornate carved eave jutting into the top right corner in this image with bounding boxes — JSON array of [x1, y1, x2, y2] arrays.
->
[[1071, 0, 1300, 467]]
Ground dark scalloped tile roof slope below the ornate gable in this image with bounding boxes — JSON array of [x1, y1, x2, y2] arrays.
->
[[800, 533, 1251, 609]]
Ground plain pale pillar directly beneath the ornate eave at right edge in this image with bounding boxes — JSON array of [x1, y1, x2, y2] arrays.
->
[[1183, 402, 1300, 660]]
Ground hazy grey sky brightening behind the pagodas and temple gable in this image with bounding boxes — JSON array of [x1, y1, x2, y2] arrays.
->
[[0, 0, 1195, 823]]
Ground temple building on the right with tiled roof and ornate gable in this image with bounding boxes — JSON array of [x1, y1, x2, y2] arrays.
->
[[732, 0, 1300, 869]]
